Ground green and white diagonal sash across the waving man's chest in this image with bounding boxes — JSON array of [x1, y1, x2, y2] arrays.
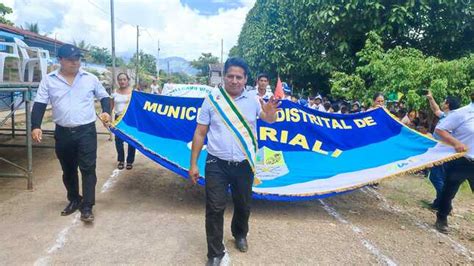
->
[[208, 88, 258, 173]]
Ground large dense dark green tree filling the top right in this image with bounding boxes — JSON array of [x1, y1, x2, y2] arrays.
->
[[230, 0, 474, 93]]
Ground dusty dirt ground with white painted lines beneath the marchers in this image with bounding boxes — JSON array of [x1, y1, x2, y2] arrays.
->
[[0, 119, 474, 265]]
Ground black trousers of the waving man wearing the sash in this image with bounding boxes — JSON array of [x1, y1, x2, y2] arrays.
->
[[205, 154, 254, 258]]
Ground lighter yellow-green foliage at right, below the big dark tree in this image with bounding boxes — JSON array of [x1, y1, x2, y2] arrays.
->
[[331, 32, 474, 109]]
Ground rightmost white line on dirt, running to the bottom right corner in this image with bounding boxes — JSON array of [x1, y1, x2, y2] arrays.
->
[[361, 187, 474, 261]]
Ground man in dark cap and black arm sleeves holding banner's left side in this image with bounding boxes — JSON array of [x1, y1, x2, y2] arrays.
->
[[31, 44, 110, 222]]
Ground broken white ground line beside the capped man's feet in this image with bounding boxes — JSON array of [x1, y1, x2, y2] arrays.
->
[[34, 169, 120, 266]]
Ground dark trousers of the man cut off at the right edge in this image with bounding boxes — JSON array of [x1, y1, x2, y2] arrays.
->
[[438, 157, 474, 218]]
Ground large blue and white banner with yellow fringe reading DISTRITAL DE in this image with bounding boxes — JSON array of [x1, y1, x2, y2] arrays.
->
[[112, 92, 462, 200]]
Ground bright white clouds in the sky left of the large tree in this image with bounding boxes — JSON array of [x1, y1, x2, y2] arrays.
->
[[6, 0, 255, 60]]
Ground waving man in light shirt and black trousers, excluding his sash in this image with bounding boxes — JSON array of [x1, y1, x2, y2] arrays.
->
[[189, 58, 279, 265]]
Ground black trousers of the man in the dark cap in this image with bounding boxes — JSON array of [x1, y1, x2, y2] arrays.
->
[[54, 122, 97, 207]]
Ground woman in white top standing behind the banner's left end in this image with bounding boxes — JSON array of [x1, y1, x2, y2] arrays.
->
[[111, 73, 135, 170]]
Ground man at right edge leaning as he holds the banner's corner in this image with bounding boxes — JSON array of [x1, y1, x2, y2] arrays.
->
[[435, 90, 474, 233]]
